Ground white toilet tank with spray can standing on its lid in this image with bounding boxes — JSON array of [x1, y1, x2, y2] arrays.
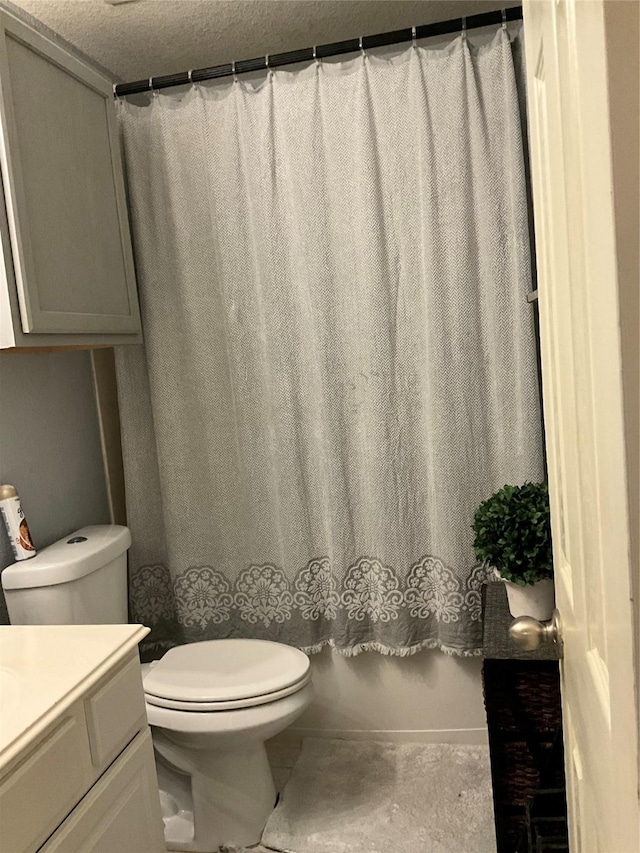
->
[[2, 524, 131, 625]]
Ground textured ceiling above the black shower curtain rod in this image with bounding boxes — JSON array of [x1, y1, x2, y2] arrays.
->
[[5, 0, 504, 80]]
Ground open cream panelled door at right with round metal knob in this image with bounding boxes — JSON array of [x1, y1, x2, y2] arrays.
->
[[524, 0, 640, 853]]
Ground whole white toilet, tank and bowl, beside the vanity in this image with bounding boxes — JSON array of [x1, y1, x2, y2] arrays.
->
[[2, 525, 312, 853]]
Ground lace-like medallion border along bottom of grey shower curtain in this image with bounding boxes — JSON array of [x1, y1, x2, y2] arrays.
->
[[131, 555, 493, 657]]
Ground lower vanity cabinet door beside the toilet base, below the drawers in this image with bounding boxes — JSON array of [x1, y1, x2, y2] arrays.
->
[[40, 729, 166, 853]]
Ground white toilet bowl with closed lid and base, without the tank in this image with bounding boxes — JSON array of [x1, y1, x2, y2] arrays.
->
[[142, 639, 312, 853]]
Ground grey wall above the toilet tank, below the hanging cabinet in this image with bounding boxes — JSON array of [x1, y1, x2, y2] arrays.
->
[[0, 351, 109, 623]]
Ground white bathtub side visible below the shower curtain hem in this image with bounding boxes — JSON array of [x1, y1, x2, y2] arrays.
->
[[289, 649, 486, 743]]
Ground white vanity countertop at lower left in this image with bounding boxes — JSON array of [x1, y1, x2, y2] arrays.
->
[[0, 625, 149, 769]]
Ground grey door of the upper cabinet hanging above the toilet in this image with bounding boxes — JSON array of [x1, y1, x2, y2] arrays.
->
[[0, 12, 140, 334]]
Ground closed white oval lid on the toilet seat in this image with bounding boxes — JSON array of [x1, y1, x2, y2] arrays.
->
[[144, 640, 310, 703]]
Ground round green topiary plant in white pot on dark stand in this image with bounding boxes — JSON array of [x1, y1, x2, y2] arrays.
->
[[473, 483, 554, 620]]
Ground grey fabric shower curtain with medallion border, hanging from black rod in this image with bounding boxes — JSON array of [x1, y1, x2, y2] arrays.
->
[[117, 25, 542, 655]]
